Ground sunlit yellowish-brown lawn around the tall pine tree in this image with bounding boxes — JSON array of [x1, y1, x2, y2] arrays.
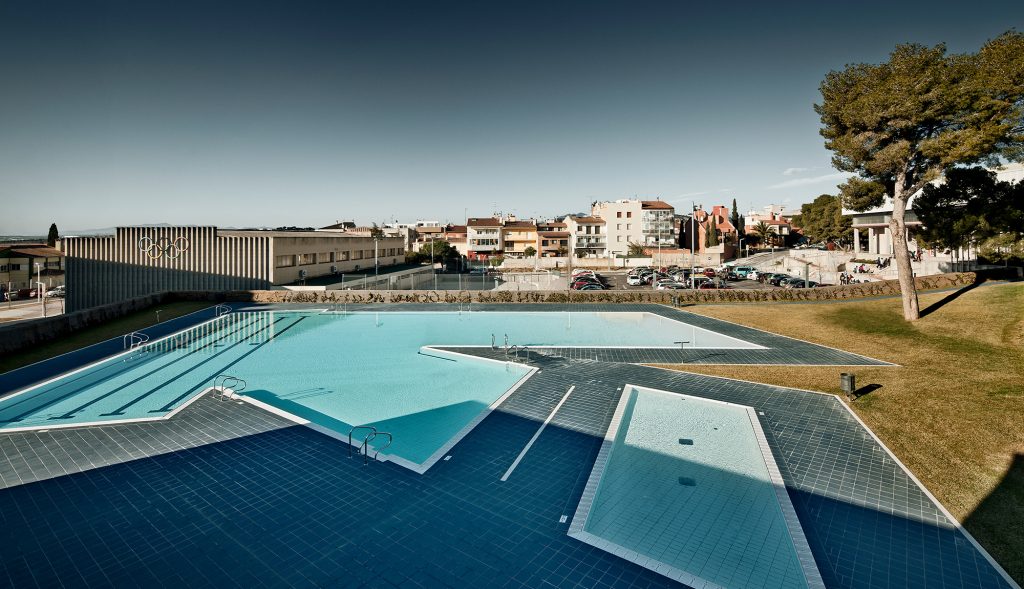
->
[[651, 284, 1024, 584]]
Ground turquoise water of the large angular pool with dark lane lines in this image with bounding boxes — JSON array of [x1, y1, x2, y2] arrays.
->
[[0, 311, 757, 464]]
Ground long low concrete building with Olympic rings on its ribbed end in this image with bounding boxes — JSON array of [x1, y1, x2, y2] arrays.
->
[[60, 226, 406, 311]]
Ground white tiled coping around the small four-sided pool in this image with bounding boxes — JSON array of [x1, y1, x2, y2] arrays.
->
[[568, 383, 825, 589]]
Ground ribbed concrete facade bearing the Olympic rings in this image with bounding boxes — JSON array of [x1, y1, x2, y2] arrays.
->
[[61, 226, 273, 311]]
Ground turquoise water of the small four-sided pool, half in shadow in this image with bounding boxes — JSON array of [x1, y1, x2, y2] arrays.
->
[[573, 387, 808, 587]]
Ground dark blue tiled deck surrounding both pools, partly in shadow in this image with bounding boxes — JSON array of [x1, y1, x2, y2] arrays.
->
[[0, 305, 1014, 588]]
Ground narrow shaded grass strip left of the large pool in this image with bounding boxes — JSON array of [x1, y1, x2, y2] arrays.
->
[[0, 301, 213, 374]]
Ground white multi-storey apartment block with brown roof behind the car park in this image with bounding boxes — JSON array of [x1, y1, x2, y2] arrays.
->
[[591, 199, 676, 255]]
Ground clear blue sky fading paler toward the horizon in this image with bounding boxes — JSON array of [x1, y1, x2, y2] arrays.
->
[[0, 0, 1024, 235]]
